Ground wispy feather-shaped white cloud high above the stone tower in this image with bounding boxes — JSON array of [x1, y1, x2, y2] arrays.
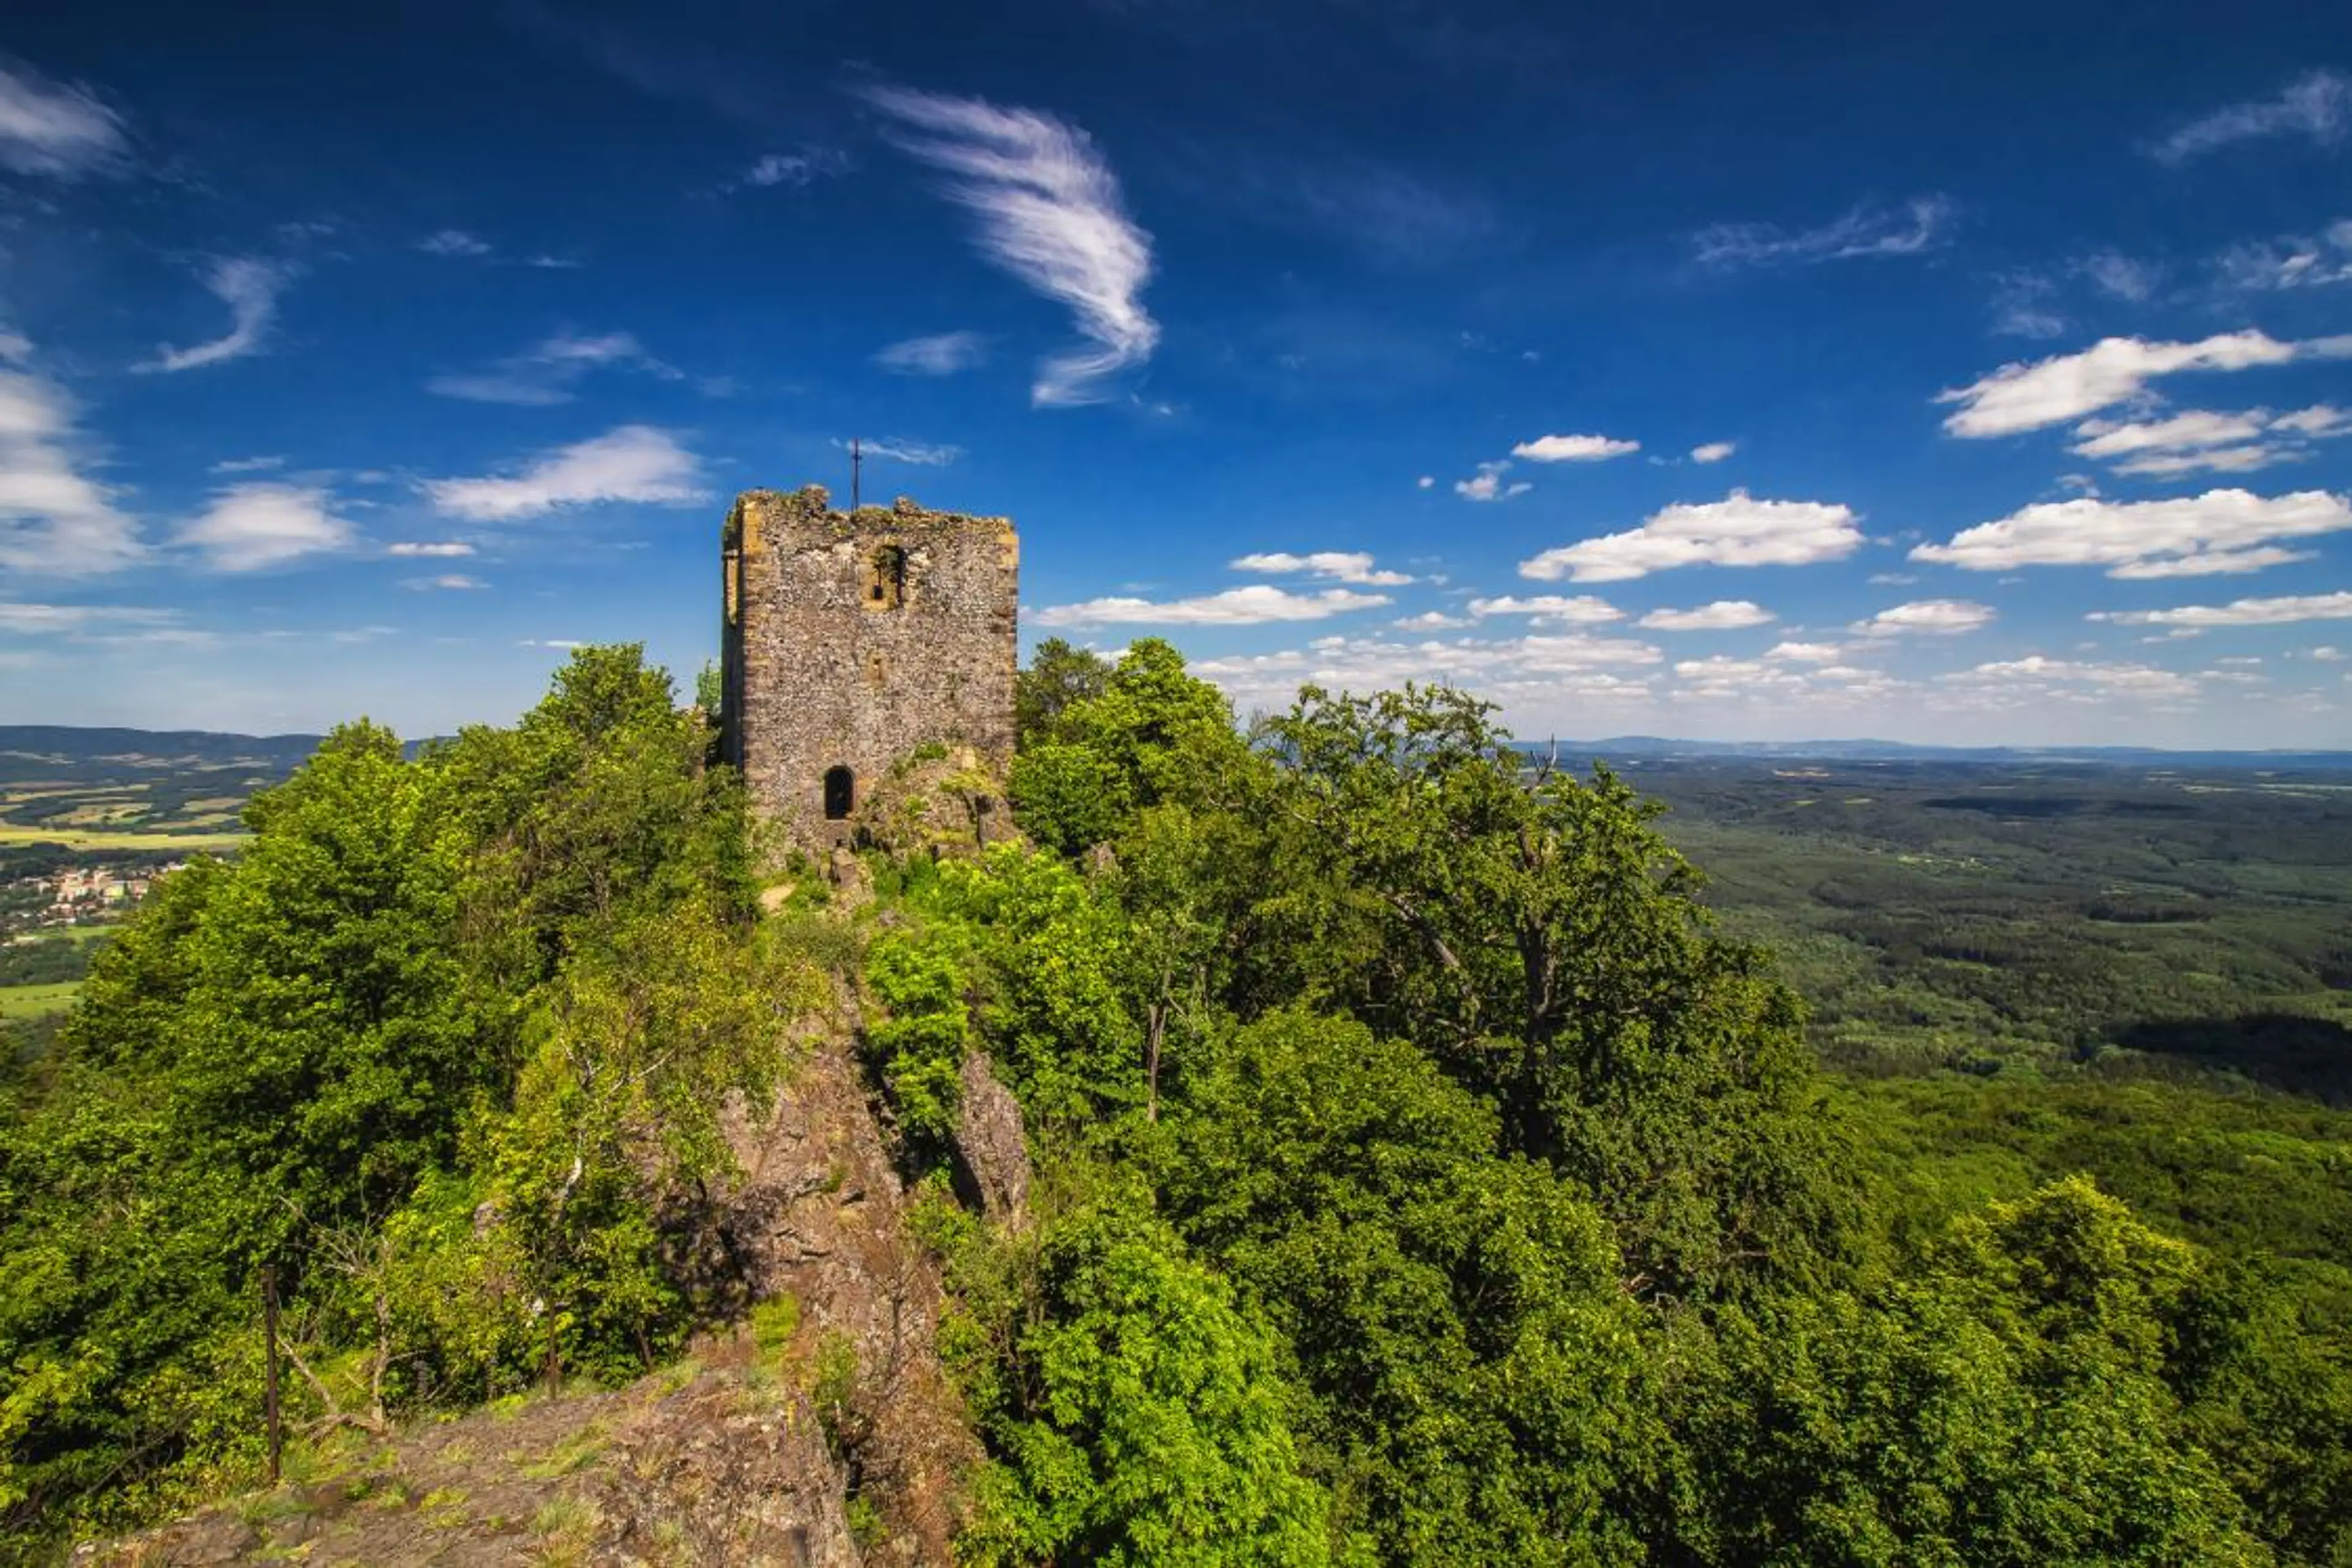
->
[[865, 87, 1159, 407]]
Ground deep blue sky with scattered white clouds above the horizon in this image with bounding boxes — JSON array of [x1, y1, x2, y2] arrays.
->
[[0, 0, 2352, 748]]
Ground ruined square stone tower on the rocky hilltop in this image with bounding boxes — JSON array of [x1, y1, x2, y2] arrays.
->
[[722, 484, 1021, 849]]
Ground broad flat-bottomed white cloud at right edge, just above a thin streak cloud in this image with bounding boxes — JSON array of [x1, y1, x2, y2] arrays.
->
[[1910, 489, 2352, 578]]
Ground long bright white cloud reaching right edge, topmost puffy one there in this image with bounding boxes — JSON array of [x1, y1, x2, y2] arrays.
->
[[1936, 326, 2352, 437]]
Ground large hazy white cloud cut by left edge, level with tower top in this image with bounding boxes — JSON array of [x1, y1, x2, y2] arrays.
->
[[0, 371, 146, 576]]
